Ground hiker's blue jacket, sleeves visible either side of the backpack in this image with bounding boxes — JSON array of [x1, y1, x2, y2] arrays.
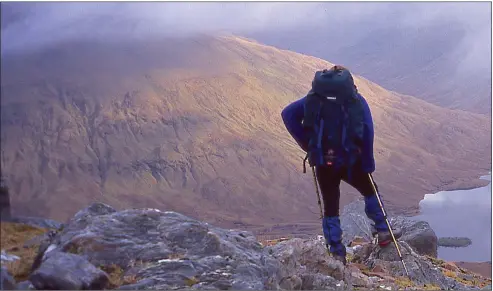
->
[[281, 94, 375, 173]]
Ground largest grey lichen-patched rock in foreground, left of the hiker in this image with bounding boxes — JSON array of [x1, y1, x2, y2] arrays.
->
[[38, 203, 279, 289]]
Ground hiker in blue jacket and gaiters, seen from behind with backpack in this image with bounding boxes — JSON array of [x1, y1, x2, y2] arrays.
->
[[281, 66, 402, 264]]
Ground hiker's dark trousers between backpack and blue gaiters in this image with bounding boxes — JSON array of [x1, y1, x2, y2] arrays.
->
[[316, 163, 375, 217]]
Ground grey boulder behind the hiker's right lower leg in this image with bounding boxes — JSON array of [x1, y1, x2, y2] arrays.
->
[[341, 200, 438, 258]]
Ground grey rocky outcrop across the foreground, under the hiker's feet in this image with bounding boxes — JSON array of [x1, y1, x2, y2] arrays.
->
[[2, 203, 491, 290]]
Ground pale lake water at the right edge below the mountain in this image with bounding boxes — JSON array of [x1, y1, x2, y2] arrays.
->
[[416, 173, 492, 262]]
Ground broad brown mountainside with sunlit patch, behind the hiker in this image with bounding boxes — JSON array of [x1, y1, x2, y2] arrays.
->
[[1, 36, 491, 227]]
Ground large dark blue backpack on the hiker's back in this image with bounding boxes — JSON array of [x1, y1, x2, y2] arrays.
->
[[303, 66, 364, 176]]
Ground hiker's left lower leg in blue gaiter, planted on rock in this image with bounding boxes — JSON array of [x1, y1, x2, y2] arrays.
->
[[322, 216, 346, 265]]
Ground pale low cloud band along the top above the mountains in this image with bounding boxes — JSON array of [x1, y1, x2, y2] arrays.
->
[[1, 2, 491, 85]]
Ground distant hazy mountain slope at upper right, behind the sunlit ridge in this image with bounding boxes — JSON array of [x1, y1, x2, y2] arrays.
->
[[251, 19, 491, 115]]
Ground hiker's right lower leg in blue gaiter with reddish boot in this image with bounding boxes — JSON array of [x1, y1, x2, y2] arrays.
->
[[365, 195, 402, 247]]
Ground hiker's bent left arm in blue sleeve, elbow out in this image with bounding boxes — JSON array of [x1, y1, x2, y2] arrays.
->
[[281, 97, 308, 152]]
